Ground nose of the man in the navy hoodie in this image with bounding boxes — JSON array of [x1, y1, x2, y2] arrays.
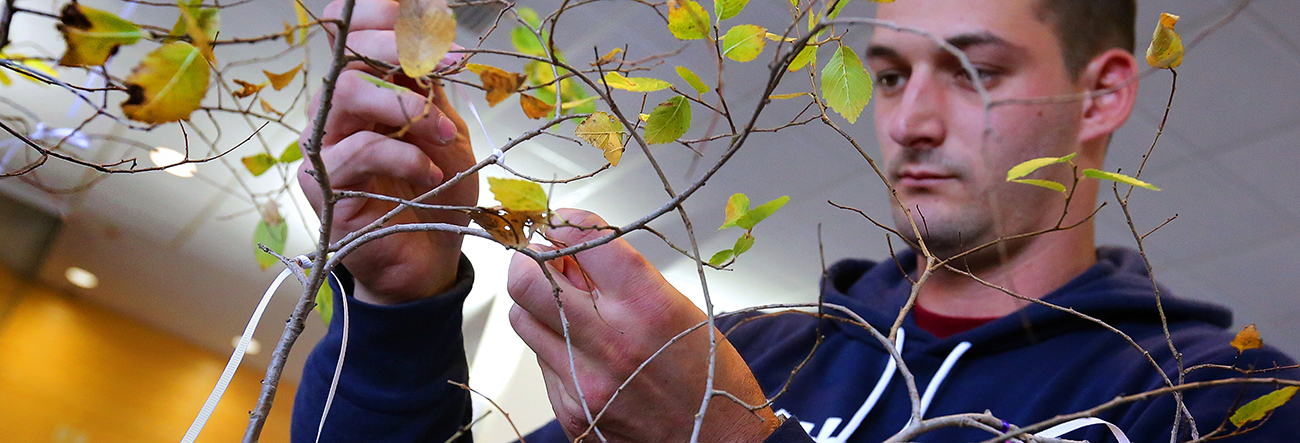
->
[[888, 70, 948, 149]]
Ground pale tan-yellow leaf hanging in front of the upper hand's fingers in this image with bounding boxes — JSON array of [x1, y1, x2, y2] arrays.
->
[[393, 0, 456, 78]]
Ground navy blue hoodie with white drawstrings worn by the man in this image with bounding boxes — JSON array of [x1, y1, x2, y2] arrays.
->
[[293, 248, 1300, 443]]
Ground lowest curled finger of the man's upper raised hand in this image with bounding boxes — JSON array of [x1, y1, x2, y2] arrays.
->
[[312, 131, 443, 190]]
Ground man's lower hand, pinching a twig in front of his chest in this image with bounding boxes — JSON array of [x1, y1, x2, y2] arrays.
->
[[508, 209, 777, 442]]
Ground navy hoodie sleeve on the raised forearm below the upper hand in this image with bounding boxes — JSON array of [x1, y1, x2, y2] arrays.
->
[[291, 256, 473, 443]]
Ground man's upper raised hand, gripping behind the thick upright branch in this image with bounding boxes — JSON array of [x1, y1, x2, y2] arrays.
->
[[298, 0, 478, 304]]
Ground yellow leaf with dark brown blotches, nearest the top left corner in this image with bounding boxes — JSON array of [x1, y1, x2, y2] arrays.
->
[[56, 3, 144, 66]]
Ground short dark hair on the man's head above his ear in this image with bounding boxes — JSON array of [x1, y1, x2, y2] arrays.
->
[[1036, 0, 1138, 79]]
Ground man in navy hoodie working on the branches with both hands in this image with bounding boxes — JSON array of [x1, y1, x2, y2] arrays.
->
[[294, 0, 1300, 443]]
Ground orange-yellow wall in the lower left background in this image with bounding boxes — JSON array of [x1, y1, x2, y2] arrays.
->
[[0, 270, 295, 443]]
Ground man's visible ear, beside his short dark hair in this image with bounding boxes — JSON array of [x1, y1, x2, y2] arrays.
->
[[1078, 48, 1138, 152]]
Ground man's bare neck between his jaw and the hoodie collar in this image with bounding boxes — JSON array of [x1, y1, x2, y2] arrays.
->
[[917, 221, 1097, 317]]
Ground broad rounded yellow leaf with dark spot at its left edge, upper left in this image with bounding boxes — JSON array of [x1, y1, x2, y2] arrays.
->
[[122, 42, 208, 123]]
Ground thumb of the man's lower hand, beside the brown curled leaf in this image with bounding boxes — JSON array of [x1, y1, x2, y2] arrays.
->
[[546, 209, 667, 296]]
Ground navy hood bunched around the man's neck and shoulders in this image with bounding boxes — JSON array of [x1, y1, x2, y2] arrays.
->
[[822, 247, 1232, 355]]
